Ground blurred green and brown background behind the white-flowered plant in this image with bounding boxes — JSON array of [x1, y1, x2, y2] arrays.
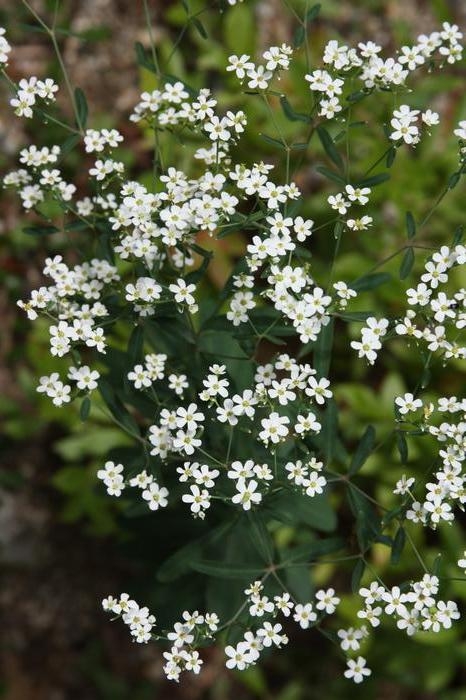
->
[[0, 0, 466, 700]]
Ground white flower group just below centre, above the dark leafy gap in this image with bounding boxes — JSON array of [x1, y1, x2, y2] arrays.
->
[[99, 353, 332, 518]]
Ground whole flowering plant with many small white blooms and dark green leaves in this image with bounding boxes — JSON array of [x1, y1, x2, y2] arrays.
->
[[0, 3, 466, 683]]
